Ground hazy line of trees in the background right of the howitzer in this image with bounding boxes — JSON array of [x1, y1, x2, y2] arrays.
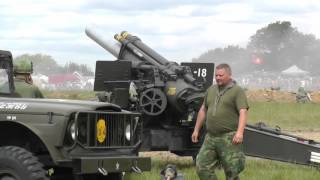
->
[[193, 21, 320, 75]]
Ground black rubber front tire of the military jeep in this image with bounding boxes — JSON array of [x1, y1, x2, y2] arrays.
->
[[0, 146, 49, 180]]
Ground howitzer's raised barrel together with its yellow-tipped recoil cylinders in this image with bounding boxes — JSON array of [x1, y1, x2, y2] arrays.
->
[[85, 27, 200, 85]]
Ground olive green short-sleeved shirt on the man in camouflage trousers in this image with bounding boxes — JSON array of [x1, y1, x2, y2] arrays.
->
[[204, 84, 249, 135]]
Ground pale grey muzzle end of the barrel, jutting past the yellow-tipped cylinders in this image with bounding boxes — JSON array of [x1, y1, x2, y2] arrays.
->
[[85, 27, 121, 58]]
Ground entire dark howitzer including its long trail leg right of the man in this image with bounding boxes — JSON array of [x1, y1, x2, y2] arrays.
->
[[86, 29, 320, 165]]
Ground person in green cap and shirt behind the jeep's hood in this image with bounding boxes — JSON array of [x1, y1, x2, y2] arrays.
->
[[13, 60, 43, 98]]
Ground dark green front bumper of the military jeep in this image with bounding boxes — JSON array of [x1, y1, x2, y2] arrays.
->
[[73, 156, 151, 175]]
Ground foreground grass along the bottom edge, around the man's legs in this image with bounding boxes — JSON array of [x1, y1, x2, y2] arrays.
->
[[125, 157, 320, 180]]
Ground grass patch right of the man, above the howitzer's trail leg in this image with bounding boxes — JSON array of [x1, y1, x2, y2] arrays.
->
[[248, 102, 320, 131]]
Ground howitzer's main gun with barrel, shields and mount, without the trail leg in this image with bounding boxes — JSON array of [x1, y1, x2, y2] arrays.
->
[[86, 28, 214, 155]]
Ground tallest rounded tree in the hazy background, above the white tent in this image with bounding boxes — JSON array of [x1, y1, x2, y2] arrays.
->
[[247, 21, 320, 71]]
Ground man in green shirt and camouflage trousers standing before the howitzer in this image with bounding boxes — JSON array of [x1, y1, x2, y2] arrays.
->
[[191, 64, 249, 180]]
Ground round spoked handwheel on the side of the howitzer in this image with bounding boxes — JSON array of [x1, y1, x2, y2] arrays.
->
[[140, 88, 167, 116]]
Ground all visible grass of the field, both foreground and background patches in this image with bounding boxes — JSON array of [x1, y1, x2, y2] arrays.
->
[[44, 91, 320, 180]]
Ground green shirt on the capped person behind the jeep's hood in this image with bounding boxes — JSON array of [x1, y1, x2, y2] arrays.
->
[[14, 79, 43, 98]]
